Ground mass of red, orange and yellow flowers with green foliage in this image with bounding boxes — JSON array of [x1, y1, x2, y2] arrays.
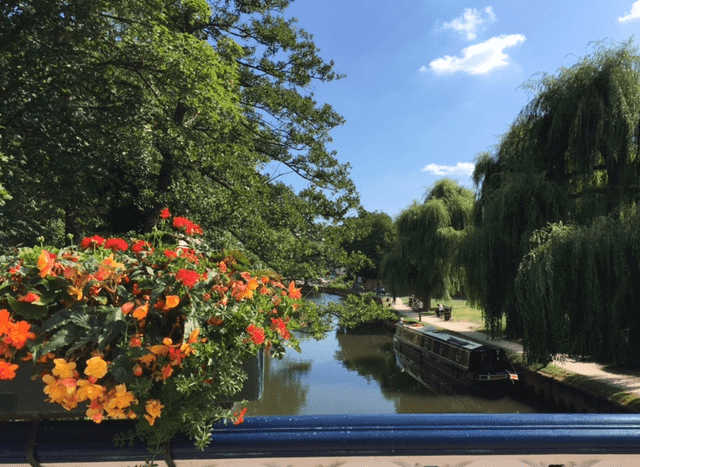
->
[[0, 209, 306, 448]]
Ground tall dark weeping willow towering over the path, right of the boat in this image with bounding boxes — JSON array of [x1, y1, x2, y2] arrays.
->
[[461, 41, 641, 361]]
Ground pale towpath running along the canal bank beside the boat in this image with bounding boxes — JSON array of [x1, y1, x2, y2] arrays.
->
[[393, 298, 641, 398]]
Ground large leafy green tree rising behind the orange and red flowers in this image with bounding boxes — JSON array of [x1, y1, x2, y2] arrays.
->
[[0, 0, 358, 275]]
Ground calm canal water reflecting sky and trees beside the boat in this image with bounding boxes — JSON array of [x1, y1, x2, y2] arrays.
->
[[247, 295, 543, 416]]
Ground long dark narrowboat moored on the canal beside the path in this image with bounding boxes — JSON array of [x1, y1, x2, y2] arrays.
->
[[393, 321, 518, 397]]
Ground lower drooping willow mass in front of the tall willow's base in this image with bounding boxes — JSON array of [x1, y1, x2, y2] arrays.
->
[[516, 204, 640, 364]]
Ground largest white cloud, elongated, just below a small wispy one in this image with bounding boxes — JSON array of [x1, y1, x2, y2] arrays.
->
[[421, 34, 526, 75]]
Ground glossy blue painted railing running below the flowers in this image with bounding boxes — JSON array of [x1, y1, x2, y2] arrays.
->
[[0, 414, 641, 465]]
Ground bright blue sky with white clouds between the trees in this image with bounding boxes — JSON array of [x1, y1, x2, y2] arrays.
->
[[286, 0, 641, 217]]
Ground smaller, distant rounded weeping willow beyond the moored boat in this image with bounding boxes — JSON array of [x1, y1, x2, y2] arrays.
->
[[381, 179, 474, 310]]
